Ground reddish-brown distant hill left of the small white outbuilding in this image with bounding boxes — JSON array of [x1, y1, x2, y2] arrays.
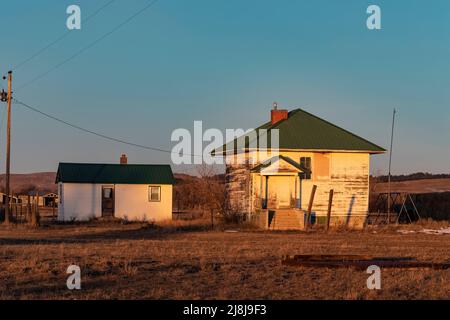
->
[[0, 172, 57, 194]]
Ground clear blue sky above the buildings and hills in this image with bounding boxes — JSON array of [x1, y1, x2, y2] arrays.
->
[[0, 0, 450, 174]]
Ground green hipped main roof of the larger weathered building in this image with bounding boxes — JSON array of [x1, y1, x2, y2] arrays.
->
[[213, 109, 386, 154]]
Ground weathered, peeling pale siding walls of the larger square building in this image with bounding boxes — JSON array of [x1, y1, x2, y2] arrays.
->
[[226, 152, 370, 227]]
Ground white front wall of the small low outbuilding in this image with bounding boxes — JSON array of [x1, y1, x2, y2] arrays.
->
[[58, 183, 172, 221]]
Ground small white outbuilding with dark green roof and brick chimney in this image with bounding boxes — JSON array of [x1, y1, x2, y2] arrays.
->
[[56, 155, 175, 221]]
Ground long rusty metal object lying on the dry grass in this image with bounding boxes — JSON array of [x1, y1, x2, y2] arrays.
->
[[281, 255, 450, 270]]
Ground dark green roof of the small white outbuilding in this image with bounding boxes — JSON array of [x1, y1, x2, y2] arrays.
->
[[56, 163, 175, 184]]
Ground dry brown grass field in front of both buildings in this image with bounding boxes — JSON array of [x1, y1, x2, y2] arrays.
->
[[0, 222, 450, 299]]
